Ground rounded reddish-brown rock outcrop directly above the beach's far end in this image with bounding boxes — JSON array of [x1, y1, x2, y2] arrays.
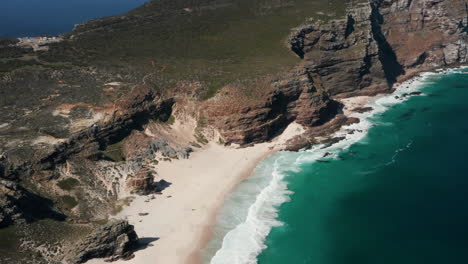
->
[[204, 68, 339, 145]]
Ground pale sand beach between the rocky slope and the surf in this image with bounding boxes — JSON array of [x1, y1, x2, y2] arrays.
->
[[87, 124, 303, 264]]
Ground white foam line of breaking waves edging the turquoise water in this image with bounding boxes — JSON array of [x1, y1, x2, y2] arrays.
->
[[210, 68, 467, 264]]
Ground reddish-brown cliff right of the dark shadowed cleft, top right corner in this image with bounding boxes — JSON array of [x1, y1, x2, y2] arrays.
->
[[373, 0, 468, 69]]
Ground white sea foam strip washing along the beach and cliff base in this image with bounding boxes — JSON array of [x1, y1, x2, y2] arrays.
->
[[206, 69, 464, 264]]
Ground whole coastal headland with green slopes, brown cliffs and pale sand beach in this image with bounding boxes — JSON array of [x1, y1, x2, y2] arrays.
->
[[0, 0, 468, 263]]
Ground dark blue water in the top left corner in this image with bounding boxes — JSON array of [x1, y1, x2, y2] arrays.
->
[[0, 0, 148, 37]]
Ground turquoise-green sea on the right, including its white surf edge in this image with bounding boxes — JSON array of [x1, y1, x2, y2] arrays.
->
[[204, 68, 468, 264]]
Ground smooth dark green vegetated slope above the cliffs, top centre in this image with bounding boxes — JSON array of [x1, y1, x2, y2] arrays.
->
[[40, 0, 345, 98]]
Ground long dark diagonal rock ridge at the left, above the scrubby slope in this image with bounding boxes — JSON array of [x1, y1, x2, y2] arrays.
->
[[0, 85, 174, 182]]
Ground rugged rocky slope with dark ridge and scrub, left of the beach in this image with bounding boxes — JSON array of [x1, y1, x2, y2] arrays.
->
[[0, 80, 174, 226]]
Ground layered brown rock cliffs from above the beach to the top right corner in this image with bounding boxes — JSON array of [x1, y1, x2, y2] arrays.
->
[[208, 0, 468, 144]]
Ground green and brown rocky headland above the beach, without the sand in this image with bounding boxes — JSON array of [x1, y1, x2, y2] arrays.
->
[[0, 0, 468, 262]]
